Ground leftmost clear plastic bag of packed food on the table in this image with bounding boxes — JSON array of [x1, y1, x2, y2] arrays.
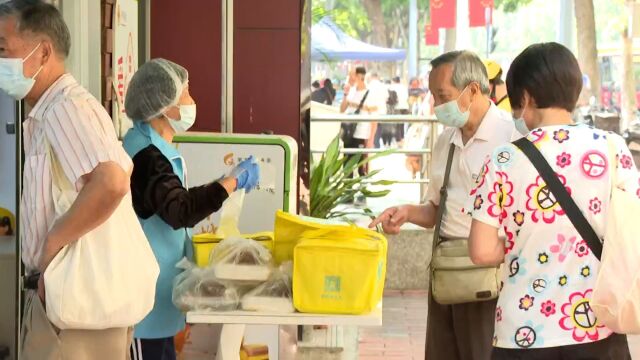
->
[[172, 259, 240, 312]]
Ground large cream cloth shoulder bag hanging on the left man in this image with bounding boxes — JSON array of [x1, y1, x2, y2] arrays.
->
[[43, 142, 160, 330]]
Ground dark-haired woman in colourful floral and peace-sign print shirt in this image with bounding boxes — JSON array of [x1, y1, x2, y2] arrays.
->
[[468, 43, 640, 360]]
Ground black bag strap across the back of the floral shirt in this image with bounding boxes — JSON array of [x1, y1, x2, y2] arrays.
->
[[513, 137, 602, 260]]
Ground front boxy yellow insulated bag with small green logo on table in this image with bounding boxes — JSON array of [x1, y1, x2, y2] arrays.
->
[[293, 226, 387, 315]]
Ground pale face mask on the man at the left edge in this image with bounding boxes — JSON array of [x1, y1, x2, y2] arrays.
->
[[0, 44, 42, 100]]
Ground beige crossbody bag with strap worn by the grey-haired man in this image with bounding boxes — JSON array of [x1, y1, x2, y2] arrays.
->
[[430, 144, 499, 305]]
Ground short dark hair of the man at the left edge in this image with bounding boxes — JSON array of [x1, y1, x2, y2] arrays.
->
[[0, 0, 71, 59]]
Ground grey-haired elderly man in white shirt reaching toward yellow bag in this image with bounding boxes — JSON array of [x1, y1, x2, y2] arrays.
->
[[371, 51, 521, 360]]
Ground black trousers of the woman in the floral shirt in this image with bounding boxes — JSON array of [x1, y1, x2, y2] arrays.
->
[[491, 334, 631, 360]]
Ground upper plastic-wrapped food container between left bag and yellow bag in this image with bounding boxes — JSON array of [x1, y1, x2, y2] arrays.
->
[[210, 237, 273, 283]]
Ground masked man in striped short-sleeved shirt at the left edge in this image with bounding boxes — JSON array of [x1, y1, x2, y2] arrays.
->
[[0, 0, 139, 360]]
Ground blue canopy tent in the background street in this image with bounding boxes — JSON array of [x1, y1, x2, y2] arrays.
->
[[311, 17, 406, 61]]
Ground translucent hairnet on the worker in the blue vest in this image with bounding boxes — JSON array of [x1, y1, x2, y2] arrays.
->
[[124, 59, 189, 121]]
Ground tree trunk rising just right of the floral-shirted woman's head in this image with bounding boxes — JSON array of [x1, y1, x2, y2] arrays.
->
[[574, 0, 600, 101]]
